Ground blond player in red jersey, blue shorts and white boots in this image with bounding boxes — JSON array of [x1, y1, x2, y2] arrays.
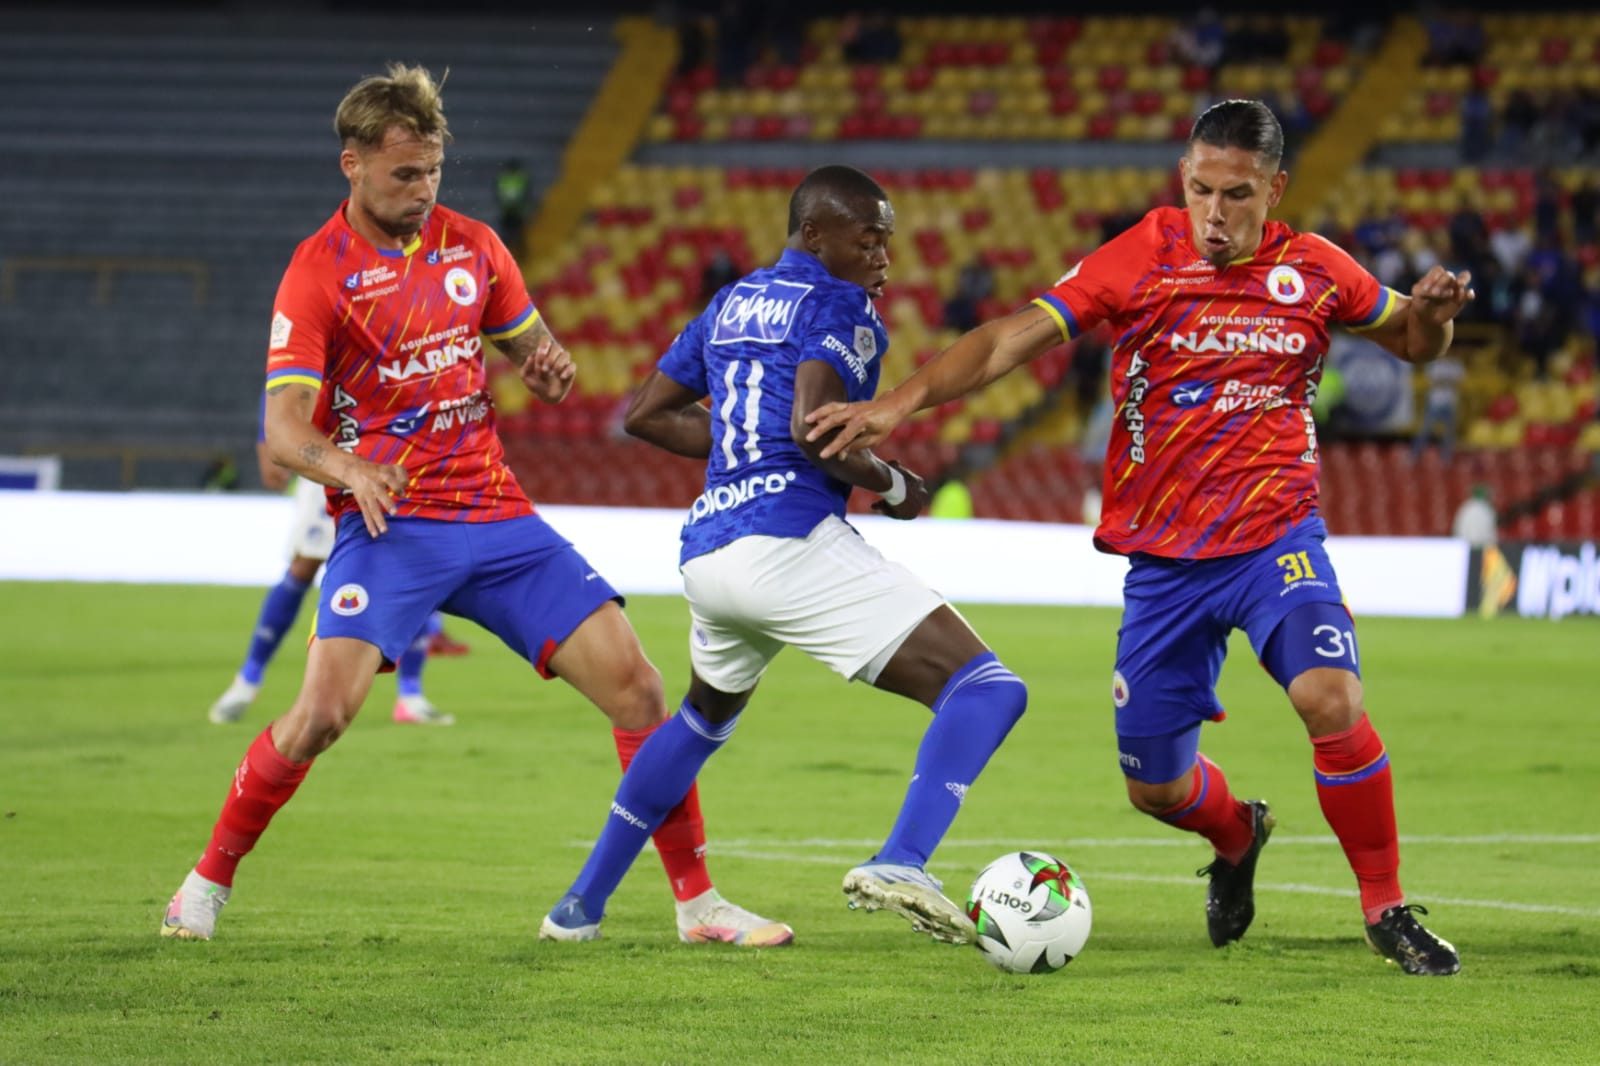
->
[[162, 66, 794, 946]]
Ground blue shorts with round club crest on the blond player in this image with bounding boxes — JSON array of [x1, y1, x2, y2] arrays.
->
[[315, 514, 622, 677]]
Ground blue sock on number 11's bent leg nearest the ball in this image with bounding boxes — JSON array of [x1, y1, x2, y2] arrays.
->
[[872, 651, 1027, 866]]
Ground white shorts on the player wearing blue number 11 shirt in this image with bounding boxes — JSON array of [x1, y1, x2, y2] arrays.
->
[[683, 515, 944, 693]]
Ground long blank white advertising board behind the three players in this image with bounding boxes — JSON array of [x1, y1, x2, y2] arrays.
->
[[0, 491, 1472, 618]]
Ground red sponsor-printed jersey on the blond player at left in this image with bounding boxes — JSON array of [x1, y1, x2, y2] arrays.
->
[[267, 203, 539, 522]]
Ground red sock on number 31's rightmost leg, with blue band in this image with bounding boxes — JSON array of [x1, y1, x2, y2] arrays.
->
[[1310, 714, 1405, 925]]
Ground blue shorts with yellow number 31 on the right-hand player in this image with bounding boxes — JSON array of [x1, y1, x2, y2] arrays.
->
[[1112, 515, 1360, 781]]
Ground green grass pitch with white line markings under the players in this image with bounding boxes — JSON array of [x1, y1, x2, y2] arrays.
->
[[0, 584, 1600, 1066]]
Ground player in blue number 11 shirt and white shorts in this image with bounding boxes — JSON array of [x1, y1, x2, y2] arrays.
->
[[539, 166, 1027, 943]]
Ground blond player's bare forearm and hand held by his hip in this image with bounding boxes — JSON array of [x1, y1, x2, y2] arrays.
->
[[264, 377, 408, 536]]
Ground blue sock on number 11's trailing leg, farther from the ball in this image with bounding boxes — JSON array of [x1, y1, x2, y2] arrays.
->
[[570, 699, 739, 922]]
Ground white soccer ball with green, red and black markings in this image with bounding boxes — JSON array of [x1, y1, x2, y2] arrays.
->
[[966, 852, 1093, 973]]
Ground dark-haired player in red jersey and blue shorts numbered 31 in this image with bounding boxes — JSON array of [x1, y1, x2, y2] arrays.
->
[[808, 101, 1472, 975]]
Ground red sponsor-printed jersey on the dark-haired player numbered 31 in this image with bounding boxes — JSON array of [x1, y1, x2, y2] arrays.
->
[[1034, 206, 1397, 559]]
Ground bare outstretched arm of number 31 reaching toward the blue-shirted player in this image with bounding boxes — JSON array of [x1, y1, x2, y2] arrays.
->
[[805, 304, 1061, 459]]
